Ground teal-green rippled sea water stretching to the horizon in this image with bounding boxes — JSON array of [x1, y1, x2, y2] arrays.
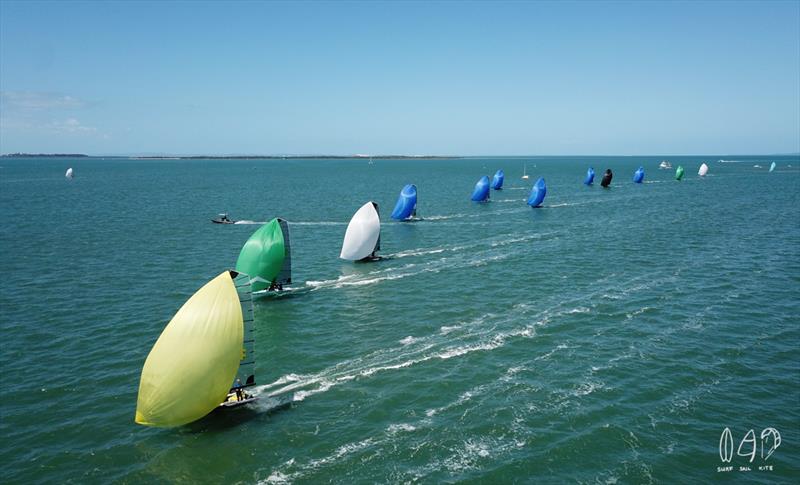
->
[[0, 157, 800, 483]]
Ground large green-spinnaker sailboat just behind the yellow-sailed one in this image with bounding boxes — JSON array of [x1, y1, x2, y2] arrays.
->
[[236, 217, 292, 292]]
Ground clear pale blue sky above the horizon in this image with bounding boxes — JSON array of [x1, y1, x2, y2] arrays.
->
[[0, 0, 800, 156]]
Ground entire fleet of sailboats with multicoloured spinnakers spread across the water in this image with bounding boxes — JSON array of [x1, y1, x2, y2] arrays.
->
[[133, 158, 764, 427]]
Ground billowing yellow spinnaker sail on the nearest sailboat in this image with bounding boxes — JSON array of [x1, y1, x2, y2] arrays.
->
[[136, 271, 244, 427]]
